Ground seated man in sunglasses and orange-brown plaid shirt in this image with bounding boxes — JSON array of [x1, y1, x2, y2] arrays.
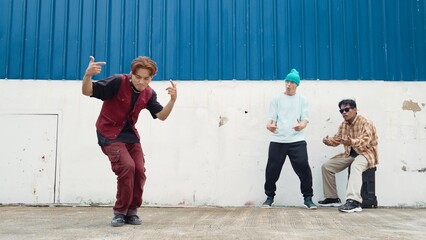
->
[[318, 99, 378, 212]]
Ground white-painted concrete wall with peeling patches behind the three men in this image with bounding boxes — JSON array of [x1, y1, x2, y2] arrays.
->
[[0, 80, 426, 207]]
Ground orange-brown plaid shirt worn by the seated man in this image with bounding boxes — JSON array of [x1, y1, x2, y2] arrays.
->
[[330, 115, 379, 168]]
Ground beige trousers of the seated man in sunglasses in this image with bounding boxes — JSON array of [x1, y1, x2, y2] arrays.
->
[[321, 155, 368, 203]]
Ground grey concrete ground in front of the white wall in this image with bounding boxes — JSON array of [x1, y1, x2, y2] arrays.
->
[[0, 205, 426, 240]]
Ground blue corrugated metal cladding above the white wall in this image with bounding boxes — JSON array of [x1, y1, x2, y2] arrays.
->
[[0, 0, 426, 81]]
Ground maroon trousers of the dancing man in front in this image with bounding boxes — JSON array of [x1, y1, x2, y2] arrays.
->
[[102, 142, 146, 216]]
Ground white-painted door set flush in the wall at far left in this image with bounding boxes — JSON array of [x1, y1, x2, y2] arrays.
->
[[0, 114, 58, 204]]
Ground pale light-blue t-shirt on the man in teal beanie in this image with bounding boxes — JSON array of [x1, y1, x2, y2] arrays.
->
[[269, 93, 309, 143]]
